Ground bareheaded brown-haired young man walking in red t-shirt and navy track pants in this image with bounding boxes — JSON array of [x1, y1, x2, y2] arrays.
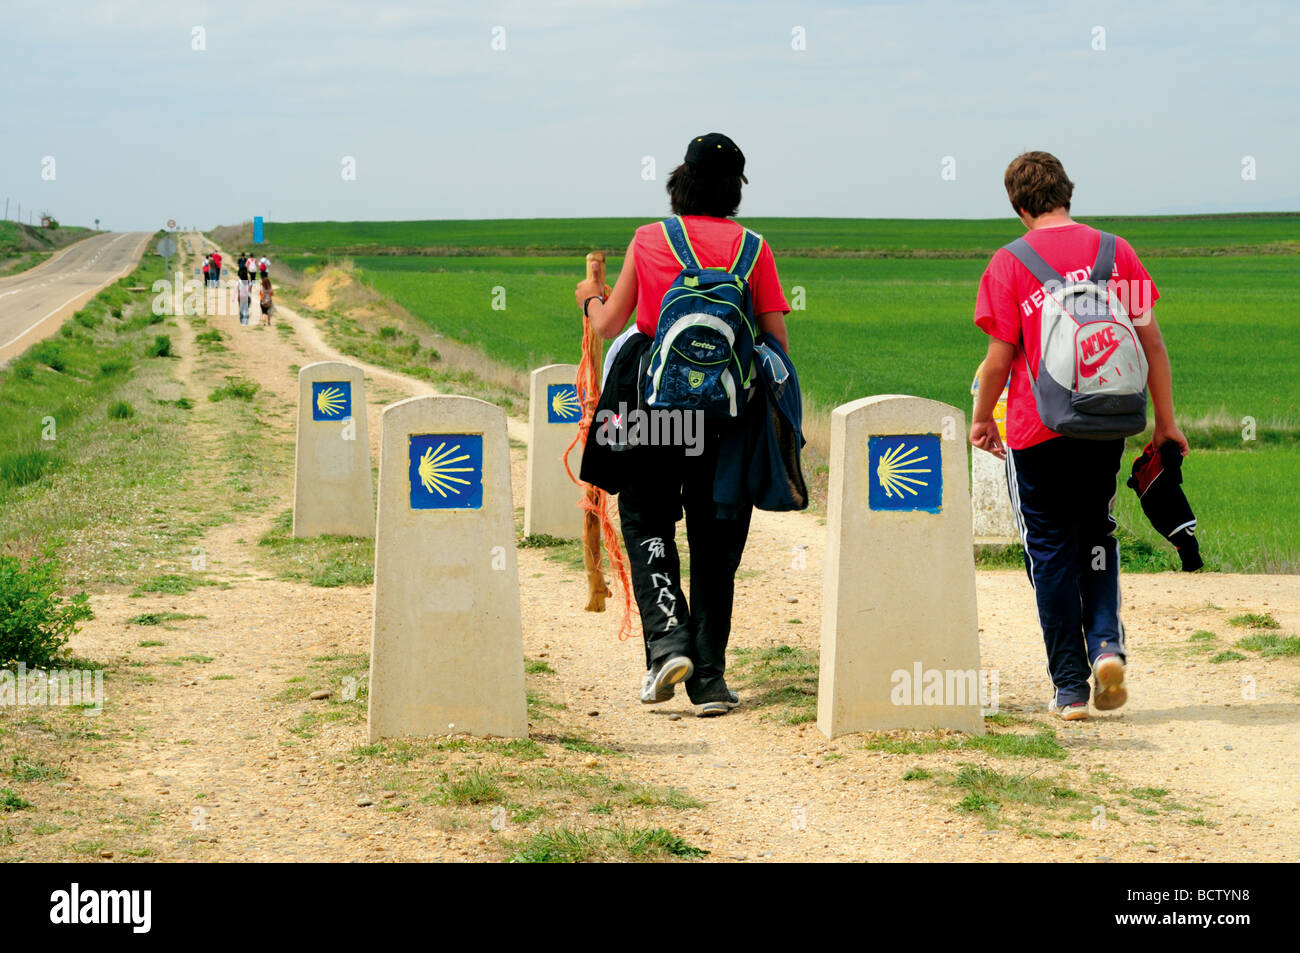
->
[[970, 152, 1187, 720]]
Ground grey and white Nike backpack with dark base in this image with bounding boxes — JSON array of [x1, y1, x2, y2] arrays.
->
[[1005, 231, 1147, 439]]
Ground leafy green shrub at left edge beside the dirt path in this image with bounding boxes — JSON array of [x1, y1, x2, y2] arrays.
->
[[0, 545, 95, 668]]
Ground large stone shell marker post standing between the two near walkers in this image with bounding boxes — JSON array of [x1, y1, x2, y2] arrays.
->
[[818, 395, 984, 737]]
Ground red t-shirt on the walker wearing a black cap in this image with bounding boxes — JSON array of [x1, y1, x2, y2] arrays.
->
[[632, 215, 790, 337]]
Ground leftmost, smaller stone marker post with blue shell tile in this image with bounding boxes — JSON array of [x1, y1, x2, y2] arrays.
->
[[294, 360, 374, 538]]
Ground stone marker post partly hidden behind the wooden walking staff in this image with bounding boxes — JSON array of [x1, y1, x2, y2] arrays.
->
[[524, 364, 582, 540]]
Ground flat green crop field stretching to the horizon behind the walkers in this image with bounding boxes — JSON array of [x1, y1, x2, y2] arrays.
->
[[245, 215, 1300, 572]]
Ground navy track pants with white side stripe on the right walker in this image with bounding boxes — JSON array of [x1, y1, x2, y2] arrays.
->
[[1006, 437, 1125, 705]]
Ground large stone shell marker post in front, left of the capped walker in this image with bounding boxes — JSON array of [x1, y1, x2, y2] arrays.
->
[[369, 397, 528, 741]]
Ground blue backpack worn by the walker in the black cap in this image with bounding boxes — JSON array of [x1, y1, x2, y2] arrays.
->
[[644, 216, 763, 419]]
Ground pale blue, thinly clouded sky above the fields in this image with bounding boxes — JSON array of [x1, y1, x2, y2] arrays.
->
[[0, 0, 1300, 230]]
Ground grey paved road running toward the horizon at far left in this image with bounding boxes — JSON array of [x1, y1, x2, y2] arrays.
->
[[0, 231, 150, 361]]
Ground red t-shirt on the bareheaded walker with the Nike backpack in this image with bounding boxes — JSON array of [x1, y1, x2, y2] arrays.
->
[[975, 222, 1160, 450]]
